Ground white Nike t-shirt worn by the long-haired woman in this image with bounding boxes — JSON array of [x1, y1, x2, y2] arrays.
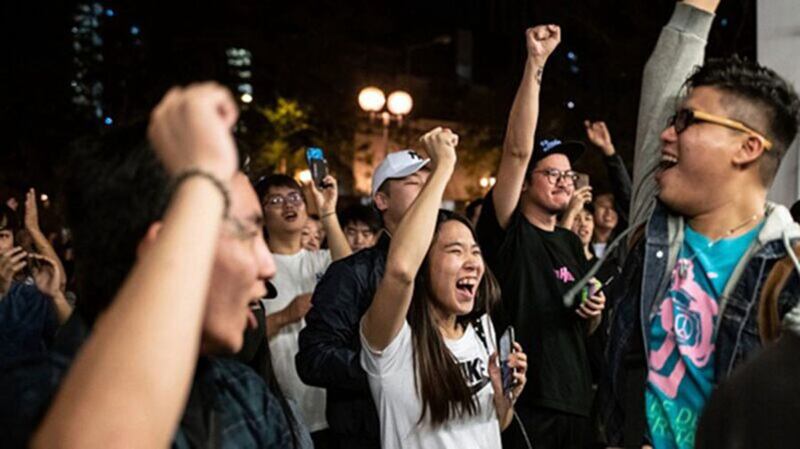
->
[[361, 315, 502, 449]]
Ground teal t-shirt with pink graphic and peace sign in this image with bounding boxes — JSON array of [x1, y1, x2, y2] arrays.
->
[[645, 225, 761, 449]]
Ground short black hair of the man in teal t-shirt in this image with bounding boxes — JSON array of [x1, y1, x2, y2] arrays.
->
[[686, 55, 800, 186]]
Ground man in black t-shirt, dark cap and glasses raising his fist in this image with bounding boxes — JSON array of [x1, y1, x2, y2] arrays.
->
[[477, 25, 605, 448]]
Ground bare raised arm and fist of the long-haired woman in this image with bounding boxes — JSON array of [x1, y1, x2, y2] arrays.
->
[[362, 128, 458, 351]]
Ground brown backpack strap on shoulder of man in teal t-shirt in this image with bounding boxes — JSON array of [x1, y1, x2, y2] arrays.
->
[[757, 243, 800, 344]]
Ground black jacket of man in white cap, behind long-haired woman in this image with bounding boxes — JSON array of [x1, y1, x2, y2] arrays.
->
[[295, 233, 390, 449]]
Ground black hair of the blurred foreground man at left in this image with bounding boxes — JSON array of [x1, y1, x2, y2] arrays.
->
[[65, 124, 170, 323]]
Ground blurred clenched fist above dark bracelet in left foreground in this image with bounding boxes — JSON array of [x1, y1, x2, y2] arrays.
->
[[147, 83, 239, 182]]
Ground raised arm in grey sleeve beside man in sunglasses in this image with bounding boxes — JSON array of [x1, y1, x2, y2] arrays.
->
[[629, 0, 719, 225]]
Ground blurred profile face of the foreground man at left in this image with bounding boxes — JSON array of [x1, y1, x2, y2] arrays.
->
[[201, 173, 275, 354]]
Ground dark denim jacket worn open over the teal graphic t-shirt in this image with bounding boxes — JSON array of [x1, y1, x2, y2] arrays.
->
[[601, 203, 800, 445]]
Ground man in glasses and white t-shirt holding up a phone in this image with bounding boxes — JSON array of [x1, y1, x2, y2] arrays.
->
[[256, 175, 350, 447]]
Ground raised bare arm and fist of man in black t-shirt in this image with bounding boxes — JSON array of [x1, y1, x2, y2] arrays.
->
[[492, 25, 561, 229]]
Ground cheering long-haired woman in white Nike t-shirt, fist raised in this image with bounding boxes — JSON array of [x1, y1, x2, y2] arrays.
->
[[360, 128, 527, 449]]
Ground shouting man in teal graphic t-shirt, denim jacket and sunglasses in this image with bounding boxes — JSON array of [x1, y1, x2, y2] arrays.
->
[[603, 0, 800, 449]]
